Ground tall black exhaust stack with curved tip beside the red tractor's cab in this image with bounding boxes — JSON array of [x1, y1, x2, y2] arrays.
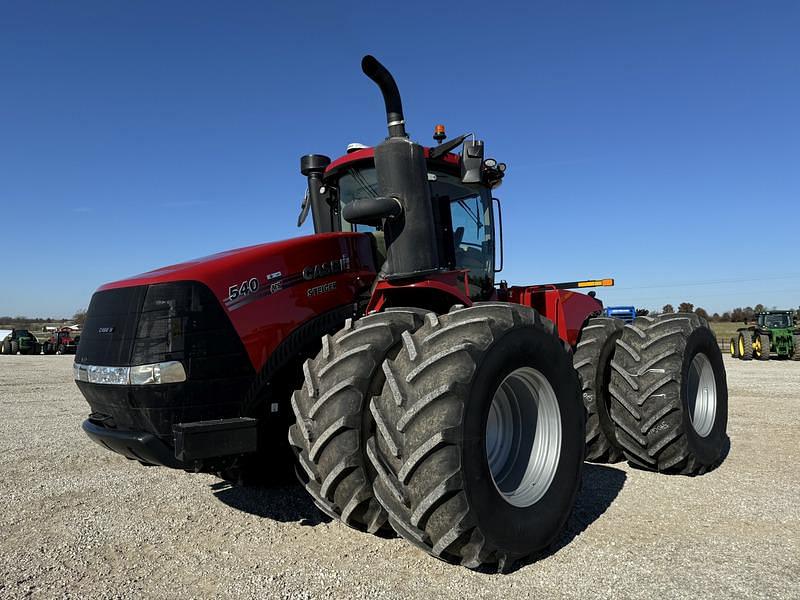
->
[[342, 55, 442, 279]]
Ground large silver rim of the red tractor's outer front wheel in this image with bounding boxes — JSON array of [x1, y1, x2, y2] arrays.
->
[[486, 367, 561, 508]]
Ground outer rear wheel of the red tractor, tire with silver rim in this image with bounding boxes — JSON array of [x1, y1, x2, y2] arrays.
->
[[611, 313, 728, 475]]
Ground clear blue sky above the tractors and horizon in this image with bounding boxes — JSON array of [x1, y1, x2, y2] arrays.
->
[[0, 1, 800, 316]]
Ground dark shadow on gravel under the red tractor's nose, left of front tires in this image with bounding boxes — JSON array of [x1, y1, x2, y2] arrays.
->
[[211, 481, 331, 527]]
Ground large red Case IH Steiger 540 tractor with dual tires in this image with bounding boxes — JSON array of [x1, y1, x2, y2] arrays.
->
[[75, 56, 727, 569]]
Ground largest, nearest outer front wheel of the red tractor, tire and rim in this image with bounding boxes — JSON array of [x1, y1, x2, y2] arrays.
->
[[367, 303, 585, 571]]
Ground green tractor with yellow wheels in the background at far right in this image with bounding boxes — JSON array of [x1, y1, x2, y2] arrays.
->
[[731, 310, 800, 360]]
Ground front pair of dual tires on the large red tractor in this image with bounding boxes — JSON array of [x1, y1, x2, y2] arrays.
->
[[290, 303, 585, 570]]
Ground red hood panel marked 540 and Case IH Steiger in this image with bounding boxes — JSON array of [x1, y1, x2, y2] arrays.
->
[[98, 233, 376, 371]]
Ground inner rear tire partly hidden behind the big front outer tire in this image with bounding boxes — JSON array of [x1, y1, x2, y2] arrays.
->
[[572, 317, 624, 463]]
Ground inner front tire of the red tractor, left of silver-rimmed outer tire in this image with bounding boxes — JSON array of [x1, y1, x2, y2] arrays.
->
[[289, 308, 425, 533]]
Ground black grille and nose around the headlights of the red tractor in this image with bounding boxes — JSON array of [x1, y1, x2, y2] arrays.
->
[[75, 281, 255, 443]]
